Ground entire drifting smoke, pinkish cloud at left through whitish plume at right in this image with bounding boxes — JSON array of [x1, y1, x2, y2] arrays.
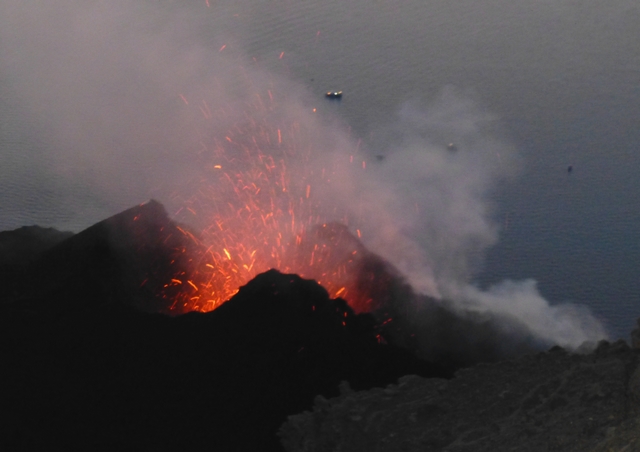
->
[[0, 0, 605, 347]]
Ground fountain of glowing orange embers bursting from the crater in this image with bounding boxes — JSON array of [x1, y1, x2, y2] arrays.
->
[[162, 91, 370, 312]]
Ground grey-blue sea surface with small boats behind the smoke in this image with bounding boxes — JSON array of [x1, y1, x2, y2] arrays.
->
[[0, 0, 640, 338]]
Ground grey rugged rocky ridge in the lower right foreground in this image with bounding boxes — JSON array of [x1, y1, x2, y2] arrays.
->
[[280, 341, 640, 452]]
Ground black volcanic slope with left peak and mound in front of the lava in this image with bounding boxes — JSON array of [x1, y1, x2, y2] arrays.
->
[[0, 218, 442, 451]]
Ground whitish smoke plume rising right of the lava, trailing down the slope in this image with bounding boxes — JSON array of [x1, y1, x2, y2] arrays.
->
[[312, 91, 606, 348]]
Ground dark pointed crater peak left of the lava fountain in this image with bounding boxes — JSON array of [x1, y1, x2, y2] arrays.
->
[[3, 201, 194, 314]]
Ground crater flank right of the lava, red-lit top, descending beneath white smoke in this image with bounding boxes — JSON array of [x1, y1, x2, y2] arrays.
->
[[288, 223, 554, 370]]
